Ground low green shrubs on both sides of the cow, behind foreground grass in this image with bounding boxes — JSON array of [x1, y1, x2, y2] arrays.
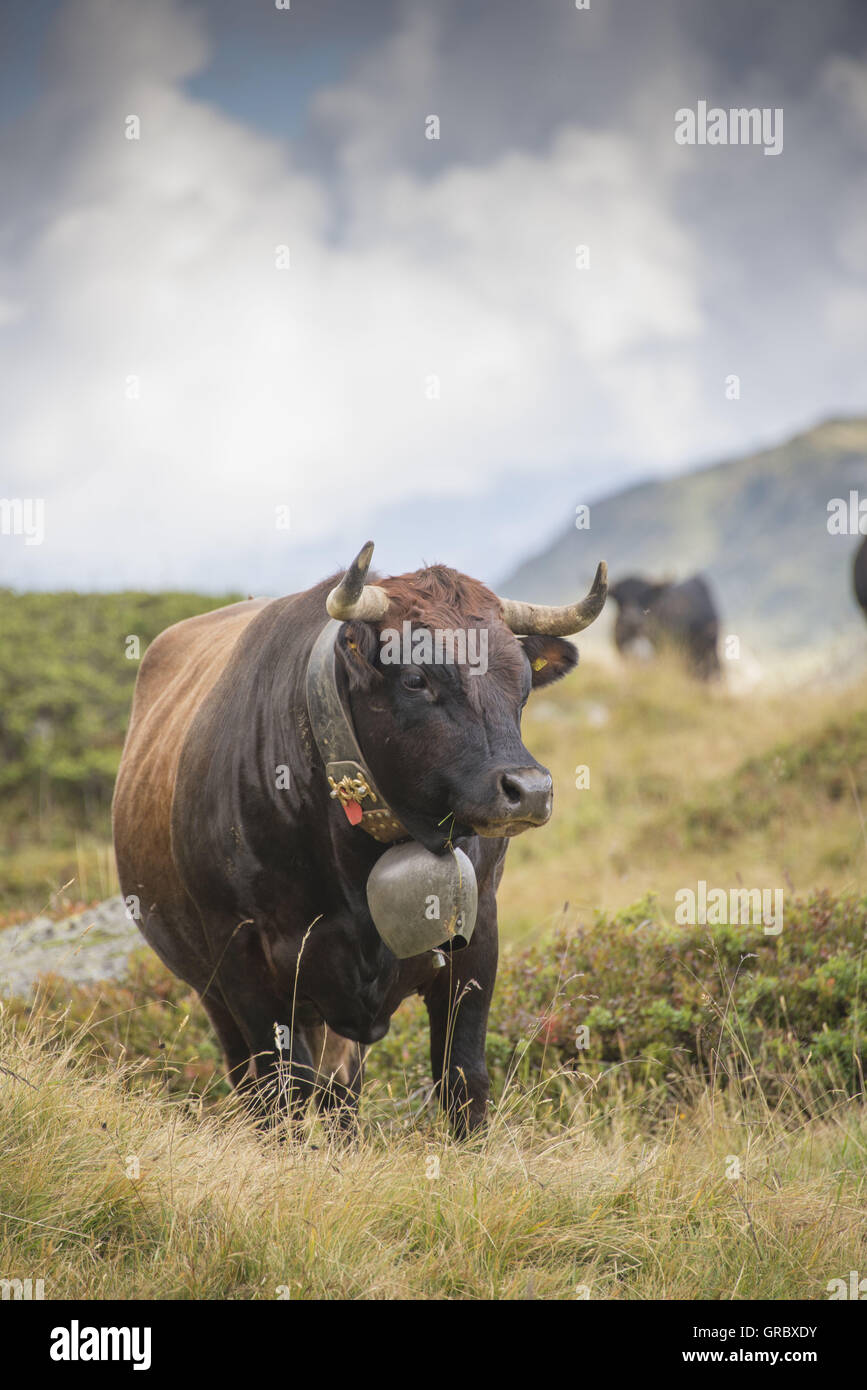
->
[[6, 894, 867, 1112]]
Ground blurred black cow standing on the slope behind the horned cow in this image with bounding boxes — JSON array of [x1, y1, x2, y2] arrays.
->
[[609, 572, 722, 680]]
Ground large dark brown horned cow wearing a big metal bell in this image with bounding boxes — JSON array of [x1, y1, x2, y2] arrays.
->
[[114, 545, 606, 1130]]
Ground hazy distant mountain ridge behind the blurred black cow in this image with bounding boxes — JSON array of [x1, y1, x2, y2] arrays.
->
[[499, 417, 867, 653]]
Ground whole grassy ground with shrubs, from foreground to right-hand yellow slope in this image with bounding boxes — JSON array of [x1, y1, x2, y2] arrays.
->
[[0, 603, 867, 1300]]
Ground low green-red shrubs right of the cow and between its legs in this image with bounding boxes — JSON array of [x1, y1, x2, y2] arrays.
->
[[371, 894, 867, 1094]]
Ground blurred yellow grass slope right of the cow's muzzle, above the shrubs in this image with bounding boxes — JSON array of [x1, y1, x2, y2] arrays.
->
[[500, 662, 867, 940]]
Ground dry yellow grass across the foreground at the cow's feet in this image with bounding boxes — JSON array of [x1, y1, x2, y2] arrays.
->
[[0, 1020, 867, 1300]]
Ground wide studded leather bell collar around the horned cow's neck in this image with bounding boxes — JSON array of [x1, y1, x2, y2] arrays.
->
[[307, 619, 410, 844]]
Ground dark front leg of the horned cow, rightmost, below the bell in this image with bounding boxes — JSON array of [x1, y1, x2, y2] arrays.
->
[[424, 938, 496, 1138]]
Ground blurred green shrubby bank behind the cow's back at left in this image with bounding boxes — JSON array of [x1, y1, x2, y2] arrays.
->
[[0, 589, 239, 913]]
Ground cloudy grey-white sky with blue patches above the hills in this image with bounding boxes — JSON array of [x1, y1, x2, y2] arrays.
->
[[0, 0, 867, 594]]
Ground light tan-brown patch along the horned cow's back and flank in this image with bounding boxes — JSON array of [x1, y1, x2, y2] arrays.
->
[[111, 599, 270, 940]]
